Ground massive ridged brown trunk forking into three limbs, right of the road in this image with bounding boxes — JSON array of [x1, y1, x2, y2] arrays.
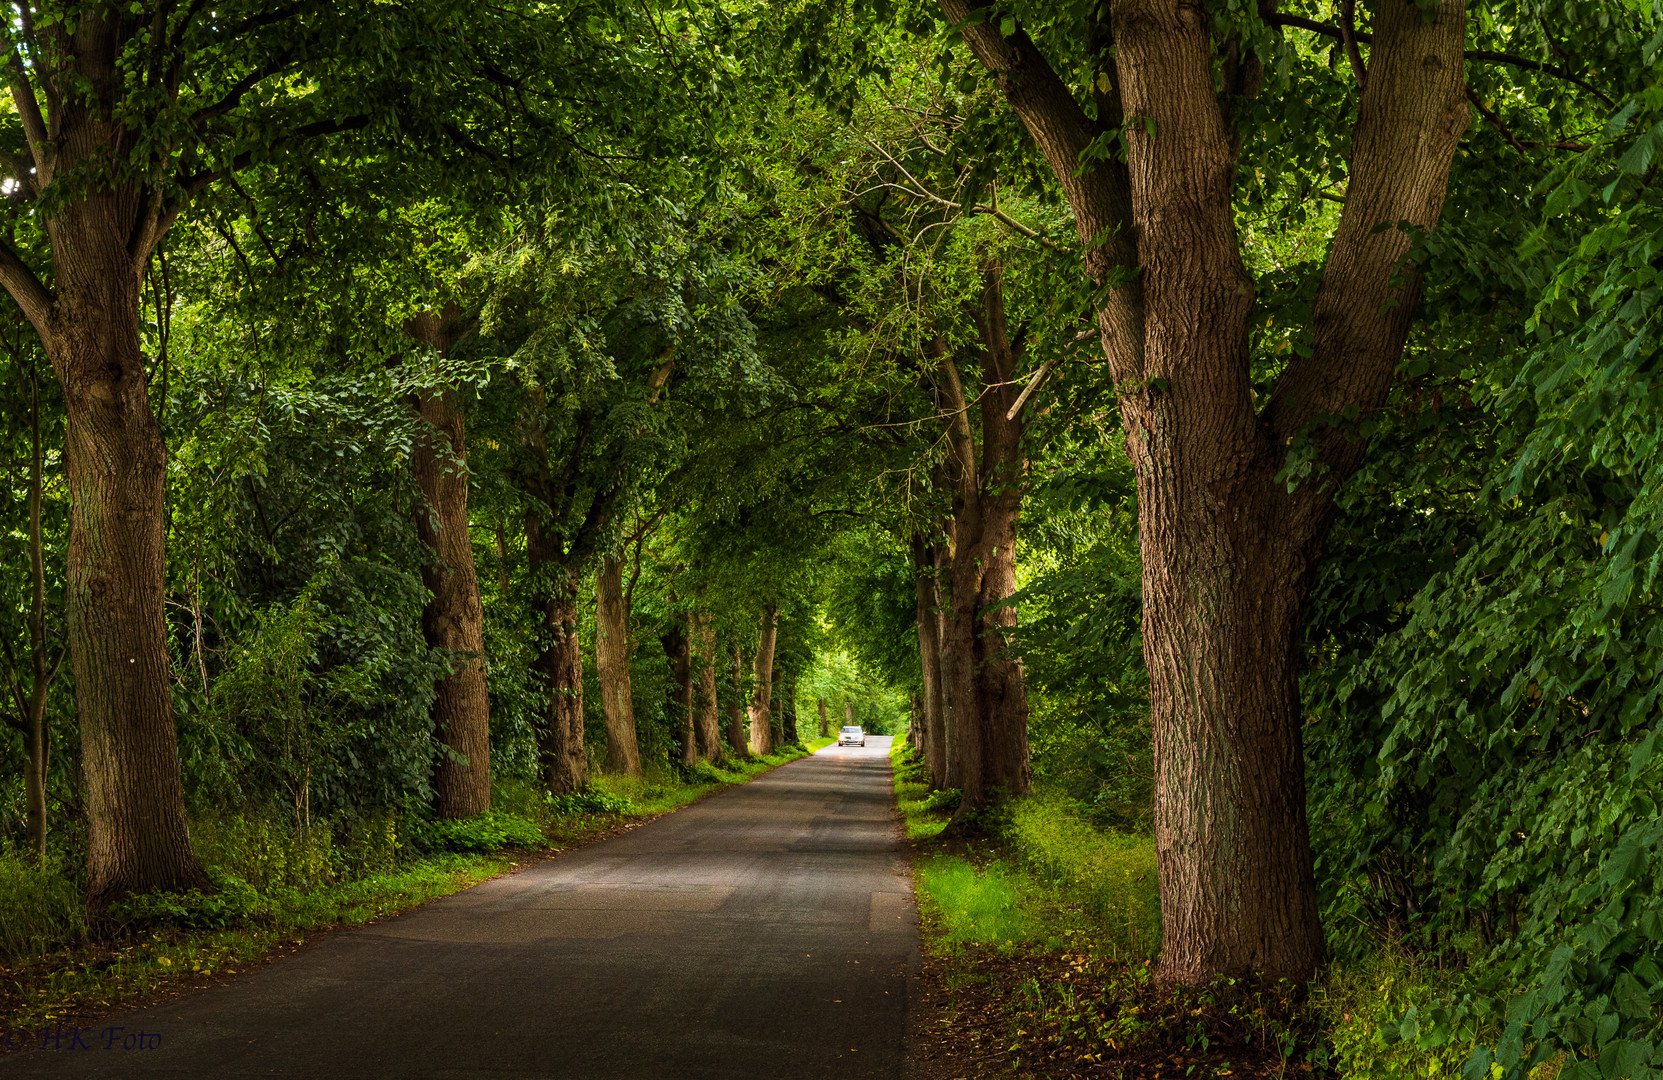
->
[[943, 0, 1468, 982]]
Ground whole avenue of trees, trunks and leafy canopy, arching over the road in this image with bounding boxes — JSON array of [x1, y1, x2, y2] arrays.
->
[[0, 0, 1663, 1077]]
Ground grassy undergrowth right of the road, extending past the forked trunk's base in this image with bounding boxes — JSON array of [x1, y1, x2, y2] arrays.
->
[[895, 741, 1569, 1080]]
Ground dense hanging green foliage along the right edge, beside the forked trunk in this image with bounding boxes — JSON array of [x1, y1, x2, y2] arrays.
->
[[1305, 77, 1663, 1078]]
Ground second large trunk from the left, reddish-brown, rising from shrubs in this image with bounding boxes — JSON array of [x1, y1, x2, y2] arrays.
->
[[406, 306, 491, 819]]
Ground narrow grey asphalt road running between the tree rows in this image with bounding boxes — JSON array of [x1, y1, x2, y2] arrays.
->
[[0, 737, 918, 1080]]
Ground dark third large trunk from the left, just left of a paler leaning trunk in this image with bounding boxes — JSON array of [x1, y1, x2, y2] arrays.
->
[[526, 529, 589, 795]]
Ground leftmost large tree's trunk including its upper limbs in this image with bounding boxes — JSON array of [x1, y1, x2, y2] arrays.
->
[[0, 21, 208, 912]]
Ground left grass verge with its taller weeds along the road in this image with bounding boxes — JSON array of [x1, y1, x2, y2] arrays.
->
[[0, 747, 803, 1053]]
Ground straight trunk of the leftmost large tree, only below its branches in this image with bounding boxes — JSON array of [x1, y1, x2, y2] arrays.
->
[[42, 242, 208, 910]]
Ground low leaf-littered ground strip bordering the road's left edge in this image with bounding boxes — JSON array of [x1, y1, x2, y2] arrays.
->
[[0, 739, 832, 1055]]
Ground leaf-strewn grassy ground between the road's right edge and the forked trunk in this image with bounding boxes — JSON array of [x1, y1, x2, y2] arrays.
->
[[896, 752, 1335, 1080]]
